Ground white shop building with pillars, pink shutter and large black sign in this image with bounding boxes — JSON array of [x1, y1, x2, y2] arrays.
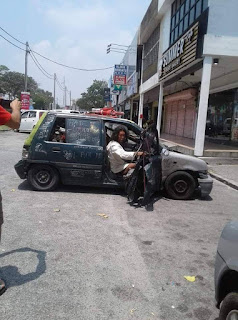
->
[[133, 0, 238, 156]]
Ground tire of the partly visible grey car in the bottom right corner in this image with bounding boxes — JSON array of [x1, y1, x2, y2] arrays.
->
[[219, 292, 238, 320]]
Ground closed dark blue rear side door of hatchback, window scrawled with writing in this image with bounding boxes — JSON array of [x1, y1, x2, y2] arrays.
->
[[47, 116, 103, 185]]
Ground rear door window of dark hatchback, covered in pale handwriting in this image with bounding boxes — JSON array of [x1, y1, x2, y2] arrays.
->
[[66, 118, 100, 146]]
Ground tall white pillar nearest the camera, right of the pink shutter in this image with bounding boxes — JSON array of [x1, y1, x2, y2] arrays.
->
[[194, 57, 212, 157]]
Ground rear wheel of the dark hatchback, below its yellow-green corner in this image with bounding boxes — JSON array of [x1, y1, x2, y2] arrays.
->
[[27, 165, 59, 191]]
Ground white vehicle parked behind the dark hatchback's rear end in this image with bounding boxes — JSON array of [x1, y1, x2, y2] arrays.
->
[[19, 110, 46, 132]]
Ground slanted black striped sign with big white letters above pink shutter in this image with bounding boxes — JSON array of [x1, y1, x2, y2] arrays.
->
[[159, 22, 199, 80]]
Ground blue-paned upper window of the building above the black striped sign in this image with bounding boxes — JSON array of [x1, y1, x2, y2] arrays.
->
[[170, 0, 208, 45]]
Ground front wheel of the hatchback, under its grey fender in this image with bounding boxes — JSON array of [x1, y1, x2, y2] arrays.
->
[[165, 171, 196, 200]]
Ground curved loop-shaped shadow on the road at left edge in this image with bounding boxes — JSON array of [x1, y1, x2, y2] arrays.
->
[[0, 248, 46, 288]]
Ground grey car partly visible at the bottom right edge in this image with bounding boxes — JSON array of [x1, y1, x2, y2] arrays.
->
[[215, 221, 238, 320]]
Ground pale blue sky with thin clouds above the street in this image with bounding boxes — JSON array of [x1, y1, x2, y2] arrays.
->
[[0, 0, 151, 104]]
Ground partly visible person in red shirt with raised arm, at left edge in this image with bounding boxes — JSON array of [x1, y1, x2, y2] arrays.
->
[[0, 100, 21, 295]]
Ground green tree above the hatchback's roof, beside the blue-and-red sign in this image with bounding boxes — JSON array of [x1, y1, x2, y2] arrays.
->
[[76, 80, 107, 110]]
